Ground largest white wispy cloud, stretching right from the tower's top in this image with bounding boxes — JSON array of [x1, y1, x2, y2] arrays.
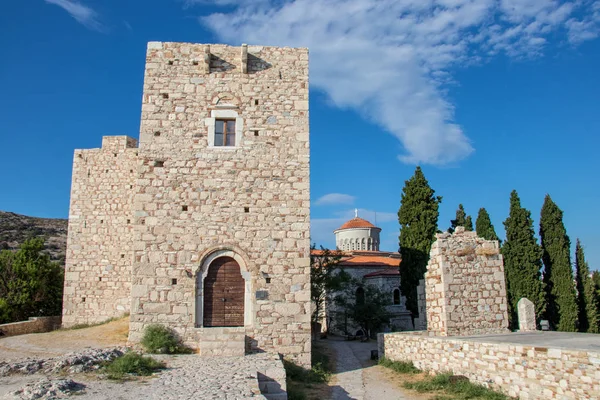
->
[[193, 0, 600, 164]]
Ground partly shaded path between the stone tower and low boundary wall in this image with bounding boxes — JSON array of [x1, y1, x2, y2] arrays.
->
[[323, 338, 426, 400]]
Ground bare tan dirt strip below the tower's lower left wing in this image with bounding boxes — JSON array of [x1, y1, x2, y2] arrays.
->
[[0, 317, 129, 361]]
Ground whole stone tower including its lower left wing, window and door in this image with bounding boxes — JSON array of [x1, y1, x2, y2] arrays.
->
[[63, 42, 310, 365]]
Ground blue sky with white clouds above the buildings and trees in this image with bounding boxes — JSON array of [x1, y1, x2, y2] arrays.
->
[[0, 0, 600, 269]]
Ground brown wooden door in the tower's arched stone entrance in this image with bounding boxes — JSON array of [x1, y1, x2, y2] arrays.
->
[[203, 257, 245, 327]]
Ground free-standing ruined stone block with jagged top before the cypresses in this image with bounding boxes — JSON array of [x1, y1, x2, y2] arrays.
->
[[425, 227, 508, 336]]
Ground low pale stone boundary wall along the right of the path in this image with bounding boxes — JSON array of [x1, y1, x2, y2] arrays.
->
[[377, 333, 600, 399]]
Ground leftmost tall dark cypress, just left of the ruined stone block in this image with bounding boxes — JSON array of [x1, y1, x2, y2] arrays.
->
[[398, 167, 442, 316]]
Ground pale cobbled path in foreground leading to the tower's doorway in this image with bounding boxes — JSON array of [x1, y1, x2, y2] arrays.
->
[[0, 354, 285, 400]]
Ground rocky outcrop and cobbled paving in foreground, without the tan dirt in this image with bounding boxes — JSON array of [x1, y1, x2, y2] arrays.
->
[[0, 349, 283, 400]]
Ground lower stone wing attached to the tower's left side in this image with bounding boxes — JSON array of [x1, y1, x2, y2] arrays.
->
[[63, 136, 138, 327]]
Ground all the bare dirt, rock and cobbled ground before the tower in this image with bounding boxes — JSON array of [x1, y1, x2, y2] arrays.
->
[[0, 318, 285, 400]]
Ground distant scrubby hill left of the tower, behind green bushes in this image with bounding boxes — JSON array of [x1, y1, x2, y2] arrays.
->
[[0, 211, 68, 266]]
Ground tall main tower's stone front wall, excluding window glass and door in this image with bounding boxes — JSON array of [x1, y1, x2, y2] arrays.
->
[[130, 42, 310, 365]]
